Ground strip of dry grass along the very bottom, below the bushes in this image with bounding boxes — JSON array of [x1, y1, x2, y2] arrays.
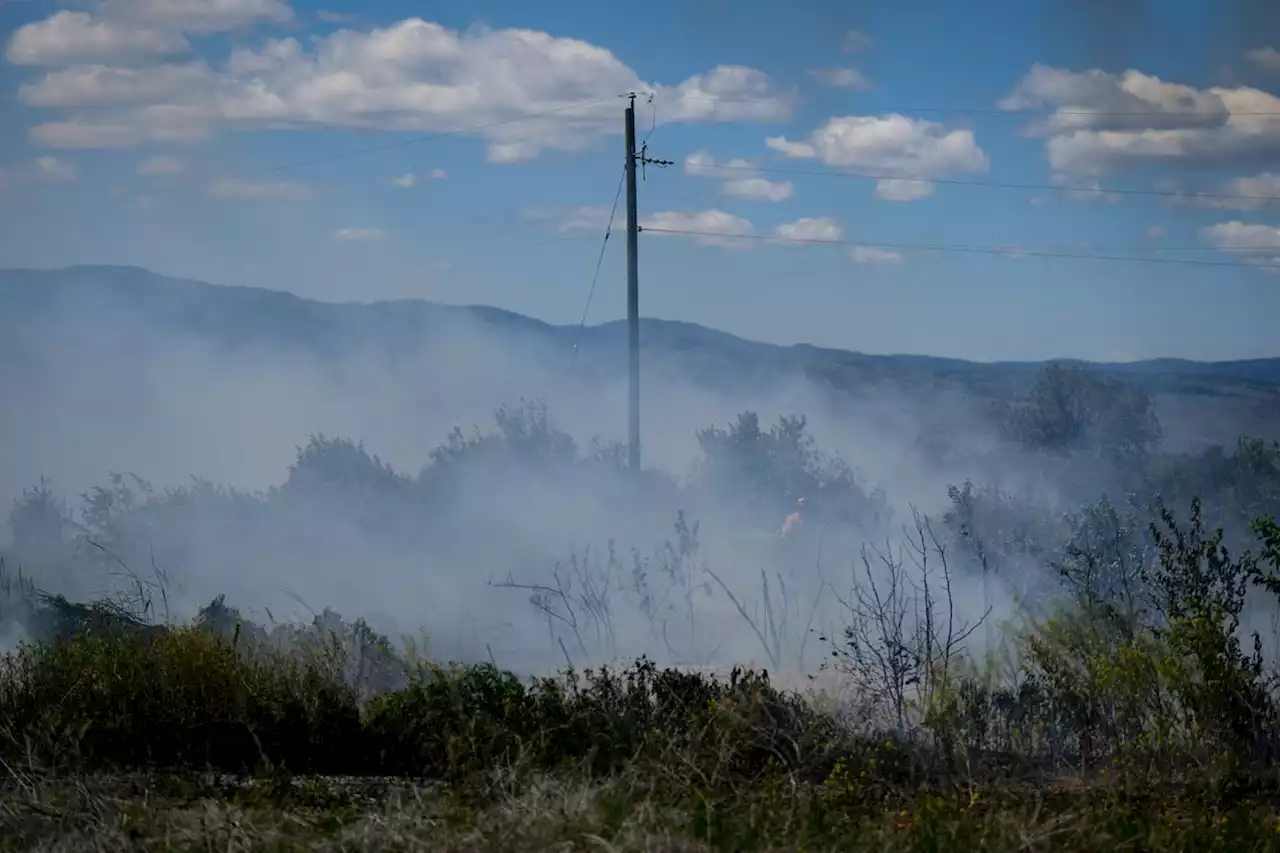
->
[[0, 775, 1280, 853]]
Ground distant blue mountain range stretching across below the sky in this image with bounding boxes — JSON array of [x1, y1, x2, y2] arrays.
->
[[0, 266, 1280, 398]]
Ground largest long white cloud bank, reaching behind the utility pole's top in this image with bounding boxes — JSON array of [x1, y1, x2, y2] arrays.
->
[[22, 17, 794, 154]]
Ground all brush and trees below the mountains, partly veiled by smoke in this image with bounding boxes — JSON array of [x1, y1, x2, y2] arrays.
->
[[0, 369, 1280, 852]]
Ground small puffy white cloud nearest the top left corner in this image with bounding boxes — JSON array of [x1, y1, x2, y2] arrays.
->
[[5, 12, 189, 67]]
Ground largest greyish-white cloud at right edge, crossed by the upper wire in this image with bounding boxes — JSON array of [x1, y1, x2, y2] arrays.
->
[[1000, 64, 1280, 175]]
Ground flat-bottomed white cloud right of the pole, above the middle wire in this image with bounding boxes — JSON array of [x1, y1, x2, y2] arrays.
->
[[765, 113, 991, 201]]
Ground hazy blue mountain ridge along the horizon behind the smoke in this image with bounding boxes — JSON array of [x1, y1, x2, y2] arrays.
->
[[0, 265, 1280, 396]]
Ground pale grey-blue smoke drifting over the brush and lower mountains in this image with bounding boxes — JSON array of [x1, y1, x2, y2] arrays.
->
[[0, 268, 1276, 669]]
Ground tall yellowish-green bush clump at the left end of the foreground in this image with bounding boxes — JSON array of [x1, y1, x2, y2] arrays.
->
[[0, 629, 360, 772]]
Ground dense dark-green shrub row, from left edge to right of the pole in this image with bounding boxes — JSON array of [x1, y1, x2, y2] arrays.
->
[[0, 612, 860, 784]]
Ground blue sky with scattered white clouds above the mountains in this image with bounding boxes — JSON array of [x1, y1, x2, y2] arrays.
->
[[0, 0, 1280, 360]]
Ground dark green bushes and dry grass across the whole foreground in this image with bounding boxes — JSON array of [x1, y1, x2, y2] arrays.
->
[[0, 612, 1280, 852]]
